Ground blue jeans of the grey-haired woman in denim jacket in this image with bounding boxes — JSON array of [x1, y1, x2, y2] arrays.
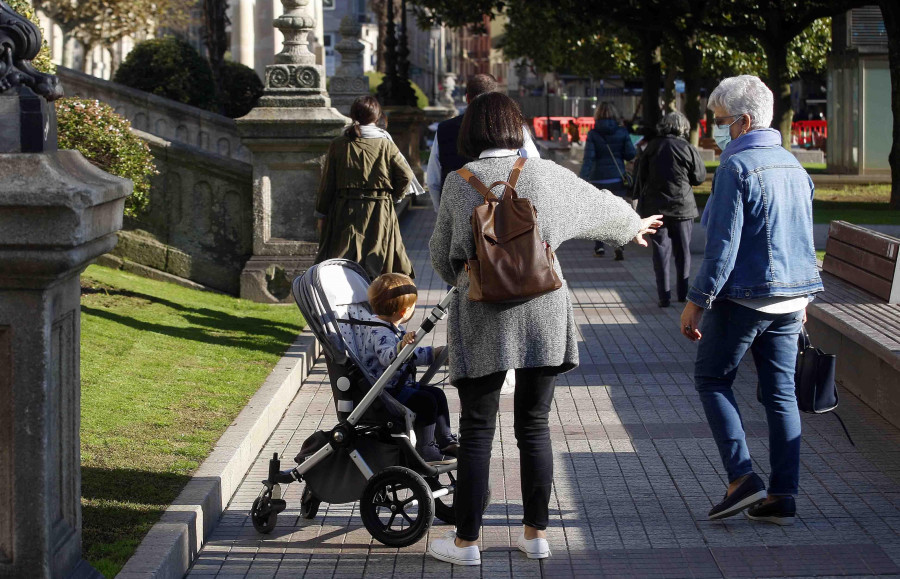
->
[[694, 299, 803, 495]]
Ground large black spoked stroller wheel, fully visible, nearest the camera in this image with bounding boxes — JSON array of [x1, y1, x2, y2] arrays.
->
[[359, 466, 434, 547]]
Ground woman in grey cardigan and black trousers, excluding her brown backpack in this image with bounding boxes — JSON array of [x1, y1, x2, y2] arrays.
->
[[428, 93, 661, 565]]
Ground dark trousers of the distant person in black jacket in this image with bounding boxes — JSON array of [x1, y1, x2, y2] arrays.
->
[[648, 217, 694, 302]]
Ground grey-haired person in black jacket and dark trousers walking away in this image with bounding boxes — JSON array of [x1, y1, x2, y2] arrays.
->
[[635, 111, 706, 308]]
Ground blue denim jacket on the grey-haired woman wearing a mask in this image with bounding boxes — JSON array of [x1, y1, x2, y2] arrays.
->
[[688, 129, 824, 309]]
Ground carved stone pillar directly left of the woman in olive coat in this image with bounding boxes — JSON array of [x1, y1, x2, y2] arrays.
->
[[237, 0, 349, 302]]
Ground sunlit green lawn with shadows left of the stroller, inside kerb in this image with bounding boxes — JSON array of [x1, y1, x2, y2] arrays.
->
[[81, 266, 303, 577]]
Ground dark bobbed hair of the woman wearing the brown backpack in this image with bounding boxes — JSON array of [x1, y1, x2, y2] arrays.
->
[[457, 92, 525, 159]]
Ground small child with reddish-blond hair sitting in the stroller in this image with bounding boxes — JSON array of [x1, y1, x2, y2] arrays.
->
[[362, 273, 459, 464]]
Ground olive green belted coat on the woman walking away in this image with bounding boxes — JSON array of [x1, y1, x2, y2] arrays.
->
[[316, 136, 415, 279]]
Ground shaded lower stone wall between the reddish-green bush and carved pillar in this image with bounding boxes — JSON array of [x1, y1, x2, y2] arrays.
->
[[113, 131, 253, 295]]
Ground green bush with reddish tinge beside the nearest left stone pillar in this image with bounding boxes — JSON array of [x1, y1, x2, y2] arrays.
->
[[56, 98, 157, 217]]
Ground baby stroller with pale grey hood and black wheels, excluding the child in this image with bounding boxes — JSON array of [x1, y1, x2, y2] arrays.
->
[[250, 259, 478, 547]]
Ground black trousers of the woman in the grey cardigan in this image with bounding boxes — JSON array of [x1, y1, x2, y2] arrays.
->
[[453, 368, 556, 541]]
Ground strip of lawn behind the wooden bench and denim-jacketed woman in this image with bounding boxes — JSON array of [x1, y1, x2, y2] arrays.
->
[[694, 184, 900, 225]]
